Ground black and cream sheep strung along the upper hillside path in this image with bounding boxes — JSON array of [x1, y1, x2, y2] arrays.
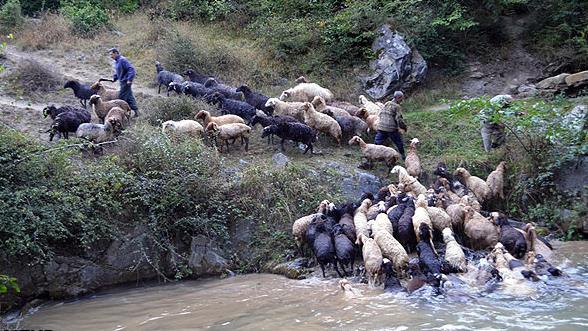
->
[[44, 62, 400, 163]]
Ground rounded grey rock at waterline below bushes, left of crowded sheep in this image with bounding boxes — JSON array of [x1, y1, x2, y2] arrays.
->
[[188, 235, 228, 275]]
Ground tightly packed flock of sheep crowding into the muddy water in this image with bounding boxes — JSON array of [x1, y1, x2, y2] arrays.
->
[[292, 160, 562, 291]]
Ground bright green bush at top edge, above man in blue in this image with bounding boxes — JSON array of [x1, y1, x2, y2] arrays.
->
[[61, 0, 110, 37]]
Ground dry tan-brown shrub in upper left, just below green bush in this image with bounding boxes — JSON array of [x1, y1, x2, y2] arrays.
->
[[18, 13, 70, 50]]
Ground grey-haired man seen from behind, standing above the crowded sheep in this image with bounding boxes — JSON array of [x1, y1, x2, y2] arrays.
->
[[375, 91, 406, 160]]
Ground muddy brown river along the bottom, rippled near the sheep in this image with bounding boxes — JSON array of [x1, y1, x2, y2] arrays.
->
[[13, 242, 588, 330]]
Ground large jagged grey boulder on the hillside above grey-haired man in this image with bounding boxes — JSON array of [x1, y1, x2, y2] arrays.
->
[[363, 25, 427, 100]]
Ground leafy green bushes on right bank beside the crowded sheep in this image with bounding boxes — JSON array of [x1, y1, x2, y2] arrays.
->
[[450, 98, 588, 239]]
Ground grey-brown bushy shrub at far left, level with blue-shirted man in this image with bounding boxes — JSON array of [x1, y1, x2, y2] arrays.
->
[[8, 59, 63, 94]]
